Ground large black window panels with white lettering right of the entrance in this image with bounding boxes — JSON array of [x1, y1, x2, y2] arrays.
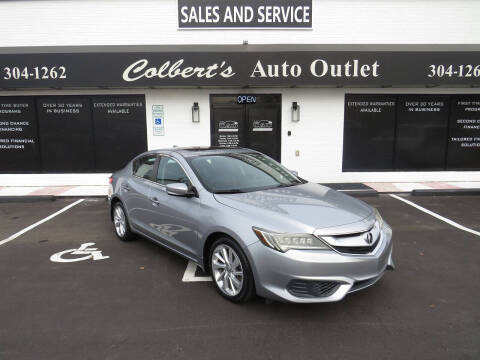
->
[[343, 94, 480, 171]]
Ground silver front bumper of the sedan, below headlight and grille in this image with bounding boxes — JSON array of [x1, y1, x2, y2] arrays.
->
[[248, 223, 393, 303]]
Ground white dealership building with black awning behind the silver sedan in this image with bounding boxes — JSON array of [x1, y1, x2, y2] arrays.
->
[[0, 0, 480, 186]]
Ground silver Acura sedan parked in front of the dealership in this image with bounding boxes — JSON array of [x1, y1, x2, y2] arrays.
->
[[109, 148, 393, 303]]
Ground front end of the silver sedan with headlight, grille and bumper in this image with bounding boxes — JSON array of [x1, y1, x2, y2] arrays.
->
[[248, 210, 393, 303]]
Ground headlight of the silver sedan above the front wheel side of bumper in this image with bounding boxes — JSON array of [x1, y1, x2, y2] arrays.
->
[[253, 227, 330, 252]]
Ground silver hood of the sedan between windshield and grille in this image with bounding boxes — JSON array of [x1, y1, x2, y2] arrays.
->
[[214, 183, 373, 231]]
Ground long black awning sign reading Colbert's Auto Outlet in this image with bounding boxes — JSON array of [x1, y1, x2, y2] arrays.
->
[[0, 45, 480, 89]]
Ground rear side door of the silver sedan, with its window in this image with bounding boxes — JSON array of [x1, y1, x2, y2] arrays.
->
[[120, 154, 157, 233]]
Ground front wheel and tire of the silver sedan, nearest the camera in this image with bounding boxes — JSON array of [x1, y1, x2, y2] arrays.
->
[[209, 237, 255, 303]]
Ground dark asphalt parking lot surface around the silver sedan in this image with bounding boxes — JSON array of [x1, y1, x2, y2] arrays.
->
[[0, 195, 480, 360]]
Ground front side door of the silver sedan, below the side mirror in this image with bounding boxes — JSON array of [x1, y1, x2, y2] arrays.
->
[[145, 155, 202, 259]]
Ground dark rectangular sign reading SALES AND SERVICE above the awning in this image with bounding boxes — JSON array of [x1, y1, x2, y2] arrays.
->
[[178, 0, 312, 29]]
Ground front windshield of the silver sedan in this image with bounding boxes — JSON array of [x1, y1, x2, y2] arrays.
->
[[190, 153, 303, 194]]
